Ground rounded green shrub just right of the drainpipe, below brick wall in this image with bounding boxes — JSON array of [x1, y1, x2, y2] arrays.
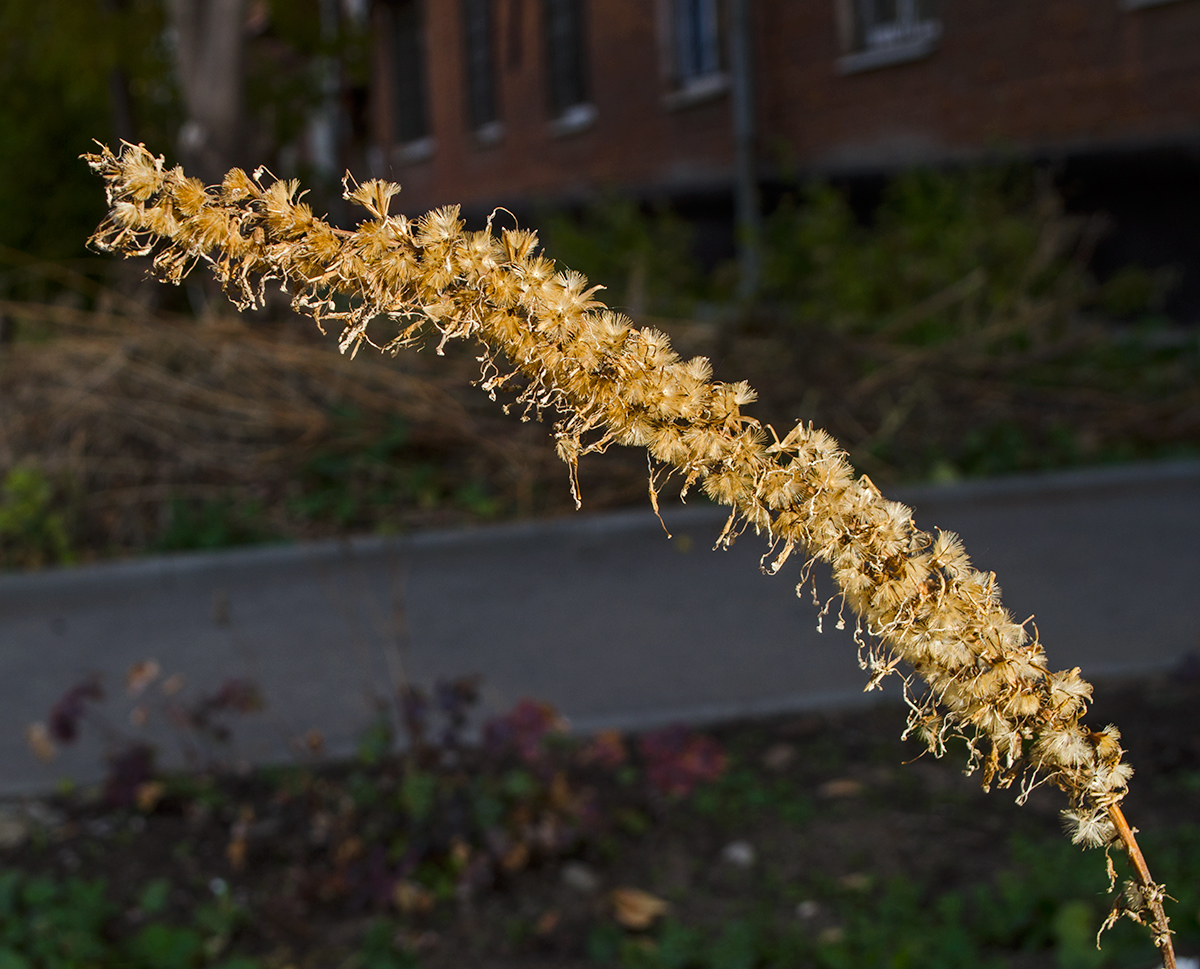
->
[[764, 167, 1090, 345]]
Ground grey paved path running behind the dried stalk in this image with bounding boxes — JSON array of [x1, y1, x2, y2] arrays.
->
[[0, 463, 1200, 793]]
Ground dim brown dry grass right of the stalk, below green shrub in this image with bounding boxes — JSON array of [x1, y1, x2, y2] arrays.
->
[[721, 304, 1200, 482]]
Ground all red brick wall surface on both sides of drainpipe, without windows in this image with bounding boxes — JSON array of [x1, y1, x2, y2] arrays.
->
[[374, 0, 1200, 211]]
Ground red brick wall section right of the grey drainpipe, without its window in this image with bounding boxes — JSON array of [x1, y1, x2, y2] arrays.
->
[[758, 0, 1200, 169]]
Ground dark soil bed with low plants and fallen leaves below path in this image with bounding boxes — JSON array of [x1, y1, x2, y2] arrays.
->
[[0, 666, 1200, 969]]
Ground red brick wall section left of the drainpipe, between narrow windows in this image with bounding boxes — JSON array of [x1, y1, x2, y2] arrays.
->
[[376, 0, 732, 210]]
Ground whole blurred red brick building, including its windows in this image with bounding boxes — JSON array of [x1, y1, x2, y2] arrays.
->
[[370, 0, 1200, 303]]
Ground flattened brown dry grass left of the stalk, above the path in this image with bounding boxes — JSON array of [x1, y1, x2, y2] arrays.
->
[[0, 278, 619, 558]]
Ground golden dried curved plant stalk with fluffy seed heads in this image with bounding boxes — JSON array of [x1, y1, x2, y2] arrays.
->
[[86, 144, 1175, 969]]
